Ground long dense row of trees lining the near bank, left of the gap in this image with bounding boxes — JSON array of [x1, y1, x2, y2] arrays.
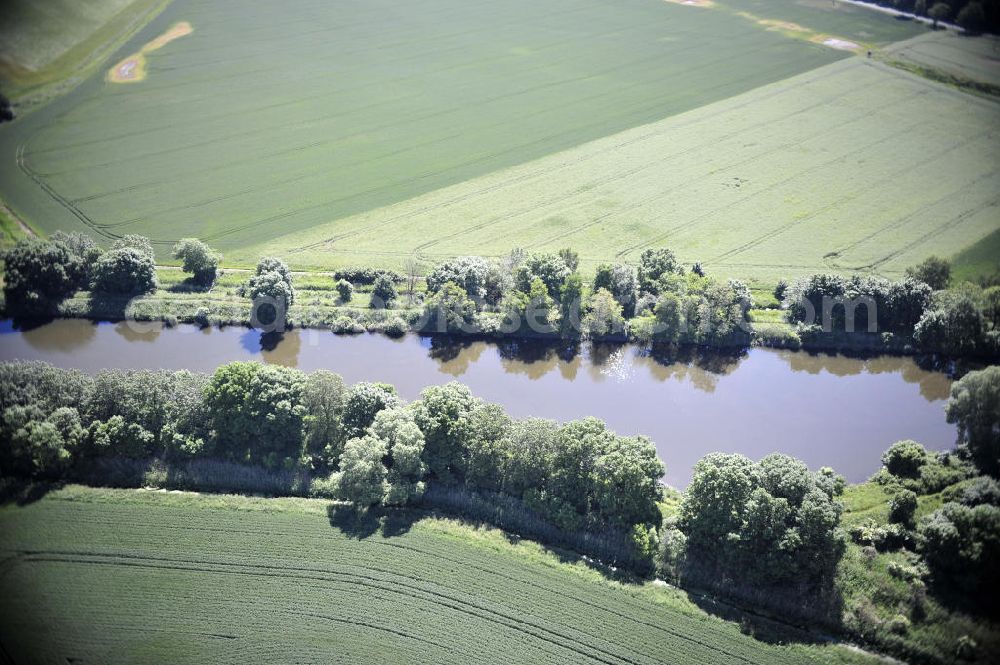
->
[[0, 362, 664, 555]]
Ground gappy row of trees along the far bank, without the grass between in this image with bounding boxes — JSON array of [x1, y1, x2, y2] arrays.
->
[[4, 232, 1000, 355]]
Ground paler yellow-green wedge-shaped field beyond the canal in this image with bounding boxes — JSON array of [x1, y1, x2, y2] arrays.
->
[[270, 58, 1000, 282]]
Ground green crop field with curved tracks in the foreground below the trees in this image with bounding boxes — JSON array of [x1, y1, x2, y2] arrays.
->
[[0, 487, 870, 665]]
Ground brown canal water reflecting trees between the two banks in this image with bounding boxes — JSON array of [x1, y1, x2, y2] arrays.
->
[[0, 320, 956, 487]]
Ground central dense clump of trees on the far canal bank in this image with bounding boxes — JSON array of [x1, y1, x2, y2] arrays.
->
[[425, 249, 753, 344]]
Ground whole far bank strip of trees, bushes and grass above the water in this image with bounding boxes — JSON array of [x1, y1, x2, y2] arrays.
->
[[4, 233, 1000, 358]]
